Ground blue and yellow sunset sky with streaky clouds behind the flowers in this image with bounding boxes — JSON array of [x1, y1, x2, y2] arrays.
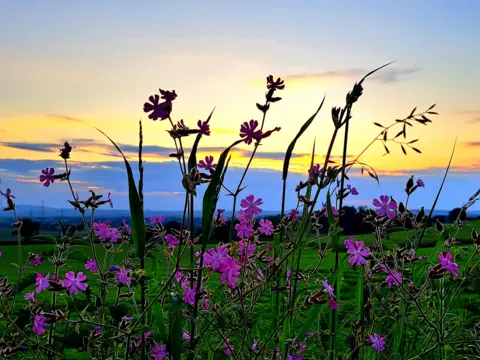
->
[[0, 0, 480, 211]]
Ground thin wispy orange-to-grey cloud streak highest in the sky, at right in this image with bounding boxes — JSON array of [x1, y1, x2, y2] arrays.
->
[[284, 67, 421, 84]]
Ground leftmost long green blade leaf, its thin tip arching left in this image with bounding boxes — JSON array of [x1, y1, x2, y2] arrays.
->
[[97, 129, 146, 258]]
